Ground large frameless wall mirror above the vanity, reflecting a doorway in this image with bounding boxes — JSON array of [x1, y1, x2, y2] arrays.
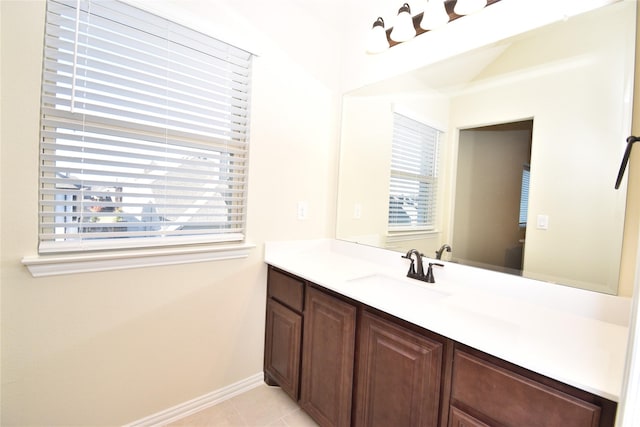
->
[[336, 1, 636, 294]]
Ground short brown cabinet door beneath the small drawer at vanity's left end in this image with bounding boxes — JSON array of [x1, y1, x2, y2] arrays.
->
[[264, 299, 302, 400]]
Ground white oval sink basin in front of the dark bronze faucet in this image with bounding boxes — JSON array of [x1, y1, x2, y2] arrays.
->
[[348, 273, 451, 299]]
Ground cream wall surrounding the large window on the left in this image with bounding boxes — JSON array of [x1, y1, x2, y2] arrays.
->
[[0, 0, 340, 426]]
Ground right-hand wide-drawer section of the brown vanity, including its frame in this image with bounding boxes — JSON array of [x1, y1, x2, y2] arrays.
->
[[449, 345, 616, 427]]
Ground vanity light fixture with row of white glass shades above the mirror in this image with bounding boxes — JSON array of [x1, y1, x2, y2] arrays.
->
[[367, 0, 500, 53]]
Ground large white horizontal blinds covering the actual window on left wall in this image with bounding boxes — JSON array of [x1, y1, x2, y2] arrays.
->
[[39, 0, 252, 252]]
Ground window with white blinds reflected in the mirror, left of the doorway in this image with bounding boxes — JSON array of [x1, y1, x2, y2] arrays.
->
[[389, 113, 441, 230]]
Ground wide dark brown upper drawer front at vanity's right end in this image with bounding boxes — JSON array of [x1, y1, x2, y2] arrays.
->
[[451, 350, 600, 427]]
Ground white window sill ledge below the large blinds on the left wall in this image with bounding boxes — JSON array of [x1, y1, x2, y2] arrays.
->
[[22, 243, 255, 277]]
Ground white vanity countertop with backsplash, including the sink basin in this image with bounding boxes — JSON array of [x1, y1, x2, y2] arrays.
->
[[265, 239, 631, 401]]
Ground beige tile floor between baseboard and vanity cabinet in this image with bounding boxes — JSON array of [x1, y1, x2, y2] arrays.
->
[[162, 384, 318, 427]]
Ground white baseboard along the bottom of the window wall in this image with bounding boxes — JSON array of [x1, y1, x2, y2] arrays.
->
[[124, 372, 264, 427]]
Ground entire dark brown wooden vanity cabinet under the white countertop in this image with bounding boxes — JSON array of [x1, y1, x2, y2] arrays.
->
[[264, 267, 617, 427]]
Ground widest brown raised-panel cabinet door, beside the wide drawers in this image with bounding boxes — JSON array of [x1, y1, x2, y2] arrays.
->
[[355, 312, 443, 427]]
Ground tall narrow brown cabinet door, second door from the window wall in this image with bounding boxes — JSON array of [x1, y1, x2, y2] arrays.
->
[[300, 287, 356, 427]]
